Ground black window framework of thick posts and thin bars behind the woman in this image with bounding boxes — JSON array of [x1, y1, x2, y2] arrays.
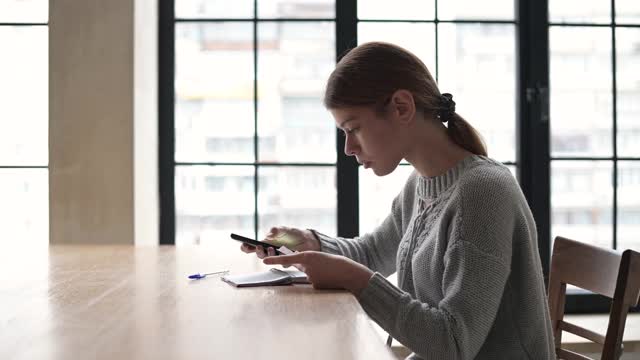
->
[[158, 0, 640, 313]]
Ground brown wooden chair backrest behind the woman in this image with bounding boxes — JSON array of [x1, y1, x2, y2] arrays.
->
[[549, 236, 640, 360]]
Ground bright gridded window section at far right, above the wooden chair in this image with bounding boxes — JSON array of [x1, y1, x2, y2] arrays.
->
[[549, 0, 640, 255]]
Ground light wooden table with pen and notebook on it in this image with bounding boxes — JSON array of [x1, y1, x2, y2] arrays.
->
[[0, 239, 394, 360]]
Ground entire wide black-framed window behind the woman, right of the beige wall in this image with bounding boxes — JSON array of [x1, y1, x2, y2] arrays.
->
[[160, 0, 640, 311]]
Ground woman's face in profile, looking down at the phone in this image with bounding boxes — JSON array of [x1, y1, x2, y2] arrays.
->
[[331, 106, 403, 176]]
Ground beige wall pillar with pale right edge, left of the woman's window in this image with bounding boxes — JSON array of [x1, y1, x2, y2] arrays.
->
[[49, 0, 158, 244]]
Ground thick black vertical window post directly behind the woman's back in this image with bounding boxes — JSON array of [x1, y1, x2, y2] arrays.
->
[[516, 0, 551, 284]]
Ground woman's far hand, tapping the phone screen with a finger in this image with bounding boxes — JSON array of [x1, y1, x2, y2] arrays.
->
[[240, 226, 320, 259]]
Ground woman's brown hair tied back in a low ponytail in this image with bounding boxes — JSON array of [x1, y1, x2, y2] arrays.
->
[[324, 42, 487, 156]]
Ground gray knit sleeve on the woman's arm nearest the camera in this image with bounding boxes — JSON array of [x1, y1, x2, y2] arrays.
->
[[358, 172, 517, 359]]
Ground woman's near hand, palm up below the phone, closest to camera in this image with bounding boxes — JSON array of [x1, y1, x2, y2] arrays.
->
[[262, 251, 373, 295]]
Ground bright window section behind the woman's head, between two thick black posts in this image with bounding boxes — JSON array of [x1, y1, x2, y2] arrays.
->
[[357, 0, 517, 233]]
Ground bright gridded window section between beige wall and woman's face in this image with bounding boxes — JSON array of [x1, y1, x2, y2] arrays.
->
[[163, 0, 337, 245]]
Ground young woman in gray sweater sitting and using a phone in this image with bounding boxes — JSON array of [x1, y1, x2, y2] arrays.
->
[[242, 43, 555, 360]]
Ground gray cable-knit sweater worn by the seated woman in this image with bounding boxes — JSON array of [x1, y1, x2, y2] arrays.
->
[[314, 155, 554, 360]]
